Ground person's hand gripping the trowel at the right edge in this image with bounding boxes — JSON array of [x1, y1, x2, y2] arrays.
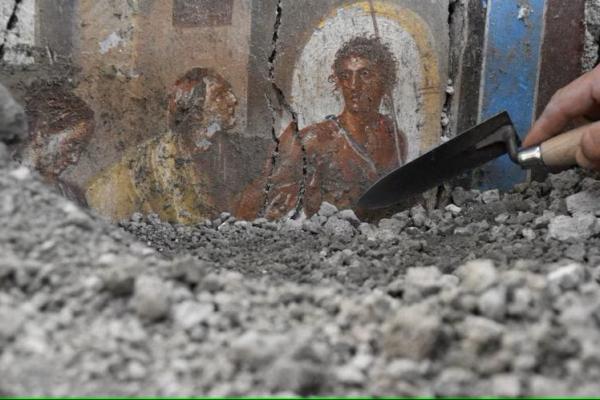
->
[[523, 66, 600, 170]]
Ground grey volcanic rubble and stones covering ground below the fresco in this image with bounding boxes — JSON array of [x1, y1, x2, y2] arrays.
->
[[0, 145, 600, 395]]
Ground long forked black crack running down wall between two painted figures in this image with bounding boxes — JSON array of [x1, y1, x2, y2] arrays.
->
[[261, 0, 308, 218]]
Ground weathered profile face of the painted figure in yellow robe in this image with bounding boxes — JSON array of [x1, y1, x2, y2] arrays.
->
[[204, 78, 237, 130]]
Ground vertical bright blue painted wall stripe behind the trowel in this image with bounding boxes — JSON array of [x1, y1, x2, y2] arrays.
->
[[480, 0, 544, 189]]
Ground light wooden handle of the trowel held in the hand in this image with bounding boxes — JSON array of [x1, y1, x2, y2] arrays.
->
[[540, 128, 585, 170]]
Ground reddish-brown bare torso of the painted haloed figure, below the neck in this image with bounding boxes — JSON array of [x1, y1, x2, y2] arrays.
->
[[265, 115, 406, 218]]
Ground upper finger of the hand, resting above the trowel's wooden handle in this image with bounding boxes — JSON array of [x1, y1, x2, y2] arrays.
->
[[523, 68, 600, 147]]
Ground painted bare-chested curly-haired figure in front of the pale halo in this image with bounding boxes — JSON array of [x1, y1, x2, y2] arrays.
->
[[237, 37, 407, 218]]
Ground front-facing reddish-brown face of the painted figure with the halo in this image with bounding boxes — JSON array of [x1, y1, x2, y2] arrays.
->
[[336, 56, 385, 114]]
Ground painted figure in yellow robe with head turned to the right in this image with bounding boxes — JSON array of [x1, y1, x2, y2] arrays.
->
[[86, 68, 237, 224]]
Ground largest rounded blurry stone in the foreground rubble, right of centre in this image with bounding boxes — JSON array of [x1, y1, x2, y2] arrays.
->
[[383, 304, 442, 361]]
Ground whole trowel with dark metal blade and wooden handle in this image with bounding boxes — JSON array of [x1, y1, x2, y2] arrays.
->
[[358, 112, 583, 209]]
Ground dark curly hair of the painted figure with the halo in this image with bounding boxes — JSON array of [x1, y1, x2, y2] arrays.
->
[[330, 36, 398, 89]]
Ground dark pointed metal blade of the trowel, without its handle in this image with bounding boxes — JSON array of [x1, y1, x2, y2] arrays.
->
[[358, 112, 512, 209]]
